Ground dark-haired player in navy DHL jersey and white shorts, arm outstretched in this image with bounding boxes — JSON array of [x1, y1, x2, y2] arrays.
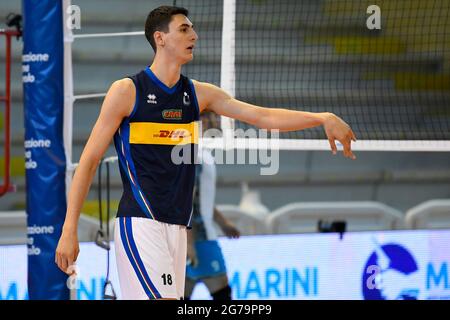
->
[[55, 6, 355, 299]]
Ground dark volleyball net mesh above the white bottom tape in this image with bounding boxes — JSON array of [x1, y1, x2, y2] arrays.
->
[[184, 0, 450, 140]]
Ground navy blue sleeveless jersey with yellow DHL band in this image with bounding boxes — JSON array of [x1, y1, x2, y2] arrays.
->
[[114, 67, 199, 226]]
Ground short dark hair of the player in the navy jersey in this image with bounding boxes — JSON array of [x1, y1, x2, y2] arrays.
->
[[145, 6, 189, 53]]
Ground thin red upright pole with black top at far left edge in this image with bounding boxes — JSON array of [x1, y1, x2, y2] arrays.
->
[[0, 13, 22, 197]]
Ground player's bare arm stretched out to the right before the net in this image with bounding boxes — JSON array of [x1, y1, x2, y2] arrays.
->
[[194, 81, 356, 159]]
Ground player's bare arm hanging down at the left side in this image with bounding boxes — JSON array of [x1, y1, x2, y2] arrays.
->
[[55, 79, 136, 272]]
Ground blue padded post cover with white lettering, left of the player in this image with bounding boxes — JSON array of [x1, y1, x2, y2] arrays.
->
[[22, 0, 69, 299]]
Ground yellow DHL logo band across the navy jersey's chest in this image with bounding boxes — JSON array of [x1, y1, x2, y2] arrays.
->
[[130, 121, 198, 145]]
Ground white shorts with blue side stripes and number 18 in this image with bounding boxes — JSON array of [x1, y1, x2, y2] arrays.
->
[[114, 217, 187, 300]]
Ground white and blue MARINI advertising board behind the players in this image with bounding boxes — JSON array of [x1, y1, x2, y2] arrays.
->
[[0, 230, 450, 300]]
